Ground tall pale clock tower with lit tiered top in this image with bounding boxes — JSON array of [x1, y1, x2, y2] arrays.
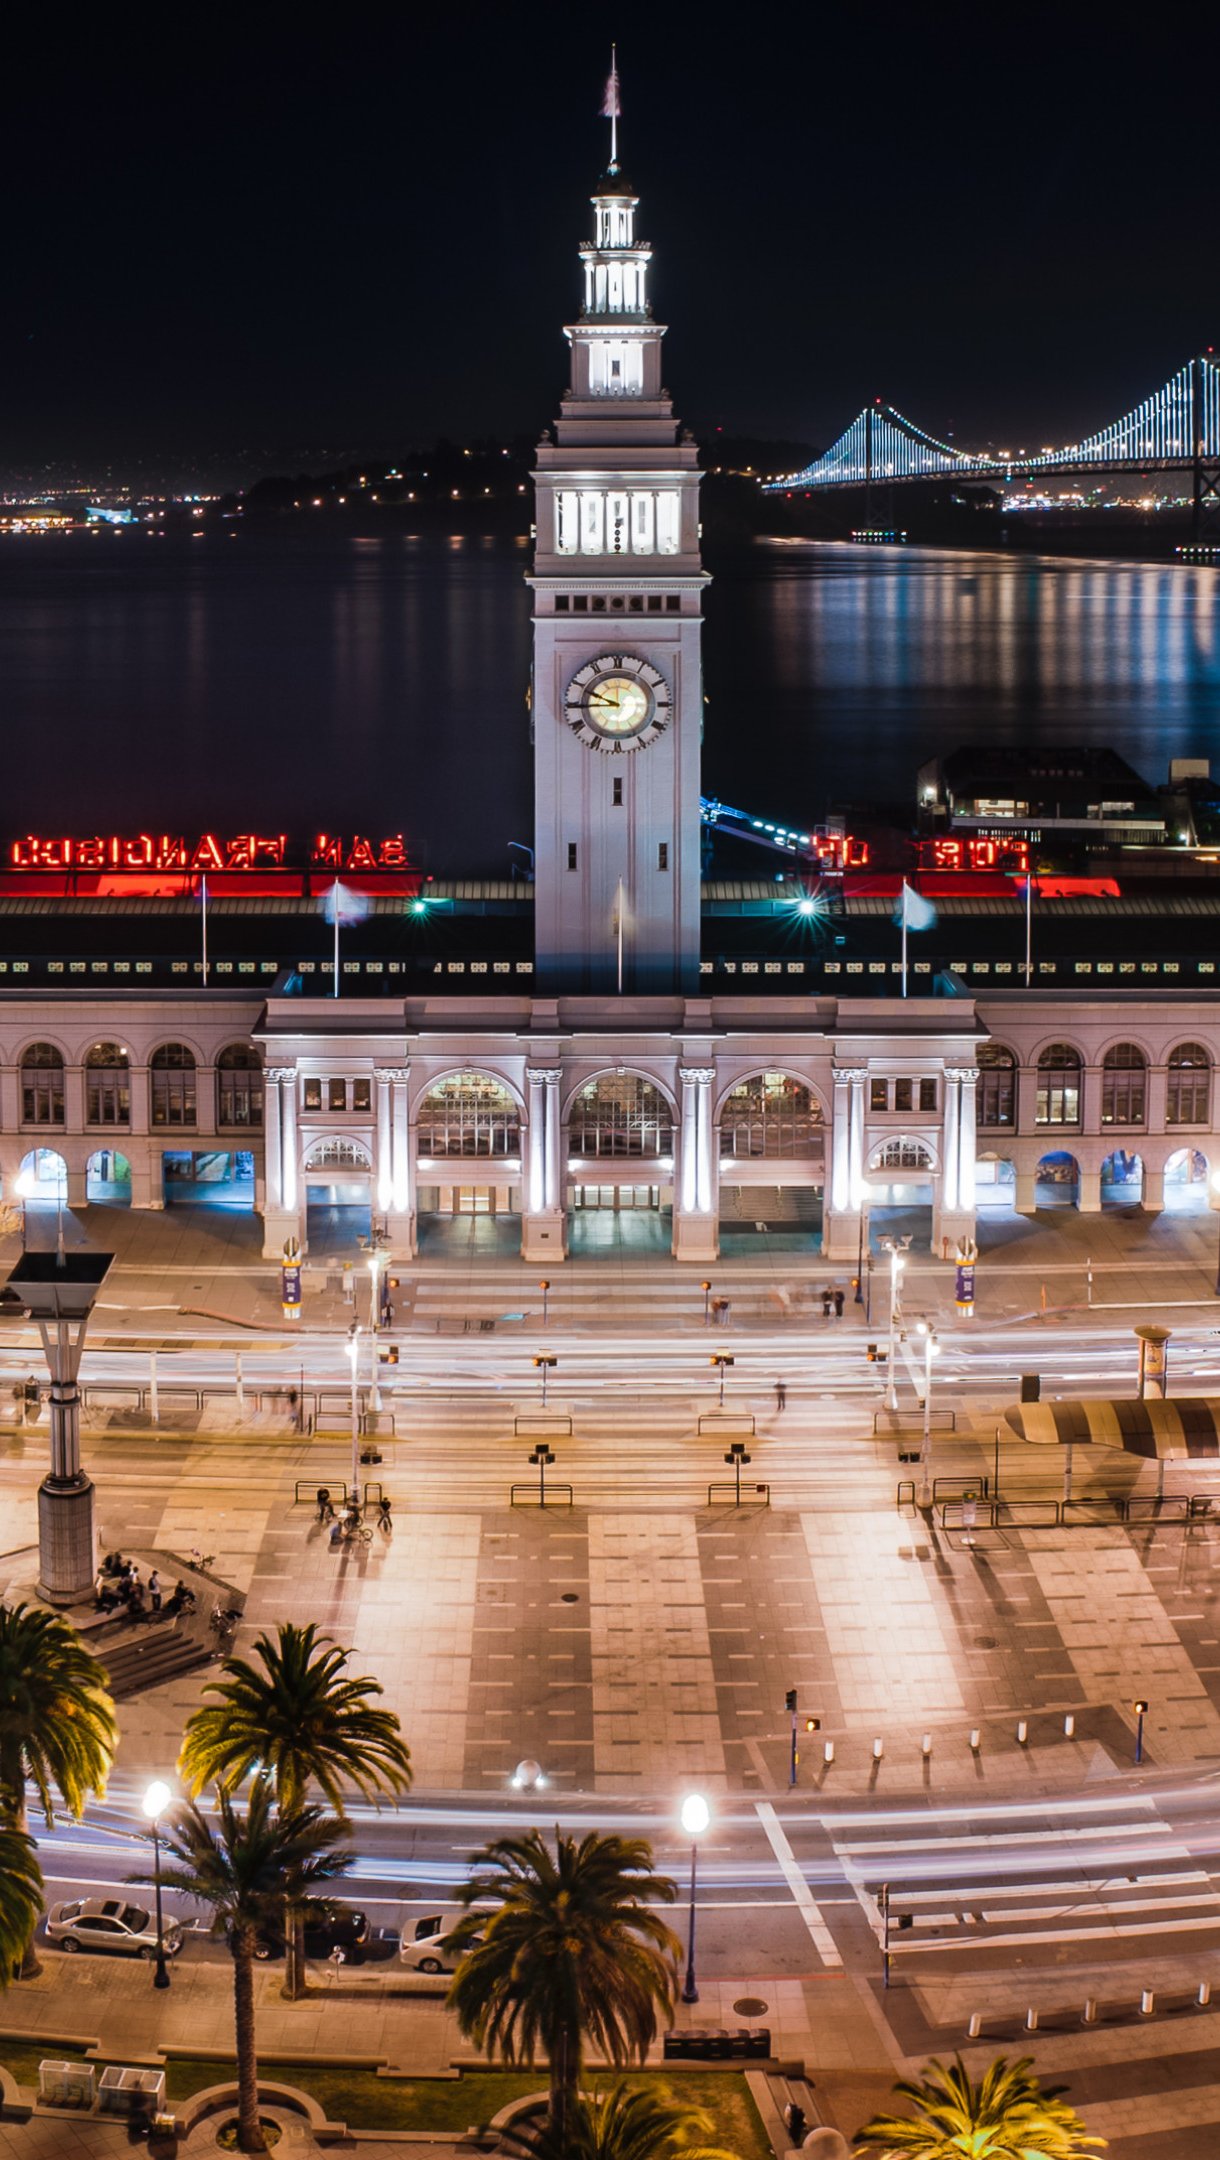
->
[[529, 139, 708, 994]]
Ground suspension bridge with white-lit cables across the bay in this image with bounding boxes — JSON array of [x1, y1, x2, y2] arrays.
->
[[767, 352, 1220, 540]]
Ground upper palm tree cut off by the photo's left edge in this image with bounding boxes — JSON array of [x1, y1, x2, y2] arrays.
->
[[0, 1605, 119, 1976]]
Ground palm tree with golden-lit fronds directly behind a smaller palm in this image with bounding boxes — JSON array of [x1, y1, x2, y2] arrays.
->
[[179, 1624, 410, 2000]]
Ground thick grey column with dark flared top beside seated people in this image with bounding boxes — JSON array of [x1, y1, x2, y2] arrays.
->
[[9, 1240, 114, 1605]]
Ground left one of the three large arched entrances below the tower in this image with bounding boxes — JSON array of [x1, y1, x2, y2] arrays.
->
[[415, 1071, 520, 1259]]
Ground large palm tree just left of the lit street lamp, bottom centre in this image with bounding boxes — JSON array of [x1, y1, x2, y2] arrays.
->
[[449, 1827, 682, 2147]]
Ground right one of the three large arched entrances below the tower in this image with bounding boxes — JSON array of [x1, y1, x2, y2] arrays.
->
[[719, 1071, 825, 1257]]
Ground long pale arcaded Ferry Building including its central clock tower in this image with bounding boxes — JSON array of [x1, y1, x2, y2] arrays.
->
[[0, 164, 1220, 1268]]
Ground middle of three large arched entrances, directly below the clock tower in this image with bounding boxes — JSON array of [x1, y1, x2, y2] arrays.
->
[[568, 1071, 676, 1257]]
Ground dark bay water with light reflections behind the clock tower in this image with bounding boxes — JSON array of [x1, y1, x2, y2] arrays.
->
[[0, 525, 1220, 873]]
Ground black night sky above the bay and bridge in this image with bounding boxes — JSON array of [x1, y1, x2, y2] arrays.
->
[[0, 0, 1220, 482]]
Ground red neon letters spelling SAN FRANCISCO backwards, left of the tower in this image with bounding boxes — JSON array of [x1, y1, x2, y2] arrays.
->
[[9, 832, 410, 875]]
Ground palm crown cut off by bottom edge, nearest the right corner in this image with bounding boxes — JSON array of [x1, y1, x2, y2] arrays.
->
[[853, 2054, 1108, 2160]]
